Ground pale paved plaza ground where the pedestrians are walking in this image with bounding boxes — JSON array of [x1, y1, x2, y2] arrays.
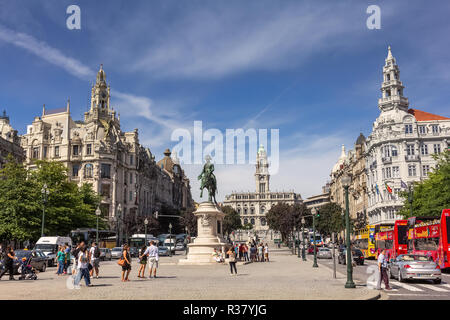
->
[[0, 249, 378, 300]]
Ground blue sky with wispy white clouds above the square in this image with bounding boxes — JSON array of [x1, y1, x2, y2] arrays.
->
[[0, 0, 450, 200]]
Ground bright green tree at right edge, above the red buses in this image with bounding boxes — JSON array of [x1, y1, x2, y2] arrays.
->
[[399, 150, 450, 218]]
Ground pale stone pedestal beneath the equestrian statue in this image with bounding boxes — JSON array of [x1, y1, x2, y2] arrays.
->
[[178, 202, 226, 265]]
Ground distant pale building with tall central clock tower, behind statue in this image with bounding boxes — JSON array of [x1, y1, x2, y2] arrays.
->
[[223, 145, 302, 233]]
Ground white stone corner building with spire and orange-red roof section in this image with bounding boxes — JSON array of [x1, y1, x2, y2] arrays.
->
[[366, 47, 450, 224]]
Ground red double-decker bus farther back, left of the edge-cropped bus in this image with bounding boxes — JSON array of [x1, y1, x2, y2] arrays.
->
[[375, 220, 408, 259]]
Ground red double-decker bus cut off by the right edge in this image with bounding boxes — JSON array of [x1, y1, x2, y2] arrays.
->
[[408, 209, 450, 269]]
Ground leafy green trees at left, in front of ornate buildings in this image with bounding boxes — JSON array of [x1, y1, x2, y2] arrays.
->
[[0, 156, 103, 242]]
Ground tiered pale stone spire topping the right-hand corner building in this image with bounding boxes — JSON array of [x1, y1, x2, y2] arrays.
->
[[378, 46, 409, 112]]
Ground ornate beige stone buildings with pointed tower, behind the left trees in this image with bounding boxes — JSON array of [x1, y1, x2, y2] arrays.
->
[[22, 66, 192, 229]]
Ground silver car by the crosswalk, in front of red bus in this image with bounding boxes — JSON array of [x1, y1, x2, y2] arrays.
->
[[389, 254, 441, 283]]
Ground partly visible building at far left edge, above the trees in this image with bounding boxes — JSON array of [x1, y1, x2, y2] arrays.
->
[[0, 111, 25, 169]]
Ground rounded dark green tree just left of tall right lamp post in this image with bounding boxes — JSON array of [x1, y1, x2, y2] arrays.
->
[[316, 202, 345, 235]]
